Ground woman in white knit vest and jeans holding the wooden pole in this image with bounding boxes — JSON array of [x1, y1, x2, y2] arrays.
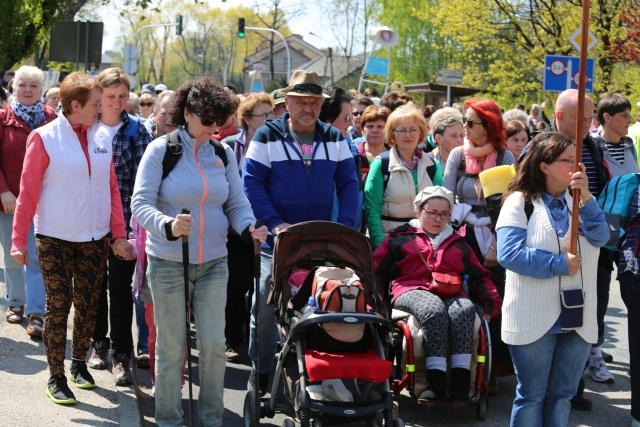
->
[[496, 132, 609, 427]]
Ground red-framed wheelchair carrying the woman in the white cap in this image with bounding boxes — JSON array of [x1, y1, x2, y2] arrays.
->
[[391, 304, 492, 420]]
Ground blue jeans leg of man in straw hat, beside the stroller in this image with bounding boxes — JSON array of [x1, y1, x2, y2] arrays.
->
[[249, 248, 278, 374]]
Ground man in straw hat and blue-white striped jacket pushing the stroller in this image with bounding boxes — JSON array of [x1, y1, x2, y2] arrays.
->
[[242, 70, 360, 394]]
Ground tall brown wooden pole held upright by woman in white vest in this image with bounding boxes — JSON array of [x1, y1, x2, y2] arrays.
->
[[569, 0, 591, 255]]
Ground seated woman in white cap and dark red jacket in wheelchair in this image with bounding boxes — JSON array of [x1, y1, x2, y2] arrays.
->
[[374, 187, 501, 402]]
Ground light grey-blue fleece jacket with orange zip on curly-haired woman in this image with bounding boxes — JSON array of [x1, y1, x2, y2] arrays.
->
[[131, 128, 255, 264]]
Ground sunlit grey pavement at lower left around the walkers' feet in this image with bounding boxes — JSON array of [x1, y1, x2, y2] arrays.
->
[[0, 271, 141, 427]]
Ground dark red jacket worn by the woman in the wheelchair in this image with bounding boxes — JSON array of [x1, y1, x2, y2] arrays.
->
[[373, 224, 502, 316]]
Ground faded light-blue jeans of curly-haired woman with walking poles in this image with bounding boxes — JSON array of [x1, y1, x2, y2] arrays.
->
[[147, 256, 228, 427]]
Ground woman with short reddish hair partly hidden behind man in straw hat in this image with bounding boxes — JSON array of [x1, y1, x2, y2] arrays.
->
[[222, 92, 273, 363]]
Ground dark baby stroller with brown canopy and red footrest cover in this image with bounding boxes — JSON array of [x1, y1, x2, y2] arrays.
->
[[245, 221, 404, 427]]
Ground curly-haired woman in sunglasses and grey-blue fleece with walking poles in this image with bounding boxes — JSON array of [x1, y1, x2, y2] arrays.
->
[[131, 77, 267, 426]]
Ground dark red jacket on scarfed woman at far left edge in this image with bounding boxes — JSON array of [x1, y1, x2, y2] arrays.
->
[[0, 104, 58, 205]]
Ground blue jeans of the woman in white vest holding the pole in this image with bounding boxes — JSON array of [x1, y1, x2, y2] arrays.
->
[[509, 331, 591, 427]]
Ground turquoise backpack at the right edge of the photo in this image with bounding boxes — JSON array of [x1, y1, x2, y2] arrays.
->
[[598, 173, 640, 251]]
